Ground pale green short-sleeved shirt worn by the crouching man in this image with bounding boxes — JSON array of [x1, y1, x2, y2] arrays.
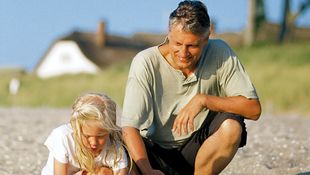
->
[[118, 40, 258, 148]]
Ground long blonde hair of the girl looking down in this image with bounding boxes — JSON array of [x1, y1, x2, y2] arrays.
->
[[70, 93, 126, 173]]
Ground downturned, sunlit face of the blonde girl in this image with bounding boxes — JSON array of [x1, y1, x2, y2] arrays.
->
[[82, 121, 109, 156]]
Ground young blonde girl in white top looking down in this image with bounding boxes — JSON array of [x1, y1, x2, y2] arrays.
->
[[42, 93, 128, 175]]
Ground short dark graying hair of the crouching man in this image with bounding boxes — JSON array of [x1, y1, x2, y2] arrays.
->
[[169, 0, 210, 35]]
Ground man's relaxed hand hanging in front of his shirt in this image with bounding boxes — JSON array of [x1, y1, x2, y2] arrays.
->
[[172, 94, 206, 135]]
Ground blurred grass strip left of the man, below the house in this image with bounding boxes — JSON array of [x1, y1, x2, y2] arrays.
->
[[0, 63, 129, 107]]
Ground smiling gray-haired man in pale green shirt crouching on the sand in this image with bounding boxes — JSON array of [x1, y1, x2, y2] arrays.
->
[[118, 1, 261, 175]]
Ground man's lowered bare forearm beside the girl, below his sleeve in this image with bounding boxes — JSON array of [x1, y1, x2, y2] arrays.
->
[[123, 127, 152, 174]]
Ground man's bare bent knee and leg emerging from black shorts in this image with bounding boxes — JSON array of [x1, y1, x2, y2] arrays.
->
[[195, 118, 242, 174]]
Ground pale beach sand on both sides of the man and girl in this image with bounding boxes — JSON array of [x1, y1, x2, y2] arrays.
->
[[0, 108, 310, 175]]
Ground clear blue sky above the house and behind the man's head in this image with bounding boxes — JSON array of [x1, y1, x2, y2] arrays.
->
[[0, 0, 310, 70]]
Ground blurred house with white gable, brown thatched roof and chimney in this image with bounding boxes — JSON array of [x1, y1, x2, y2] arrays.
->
[[34, 22, 154, 78]]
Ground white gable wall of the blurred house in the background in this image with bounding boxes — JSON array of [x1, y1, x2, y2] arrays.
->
[[37, 41, 99, 78]]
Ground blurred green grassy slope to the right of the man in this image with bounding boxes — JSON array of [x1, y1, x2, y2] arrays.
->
[[237, 42, 310, 113]]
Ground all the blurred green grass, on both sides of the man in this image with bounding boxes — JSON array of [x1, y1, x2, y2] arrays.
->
[[0, 42, 310, 113]]
